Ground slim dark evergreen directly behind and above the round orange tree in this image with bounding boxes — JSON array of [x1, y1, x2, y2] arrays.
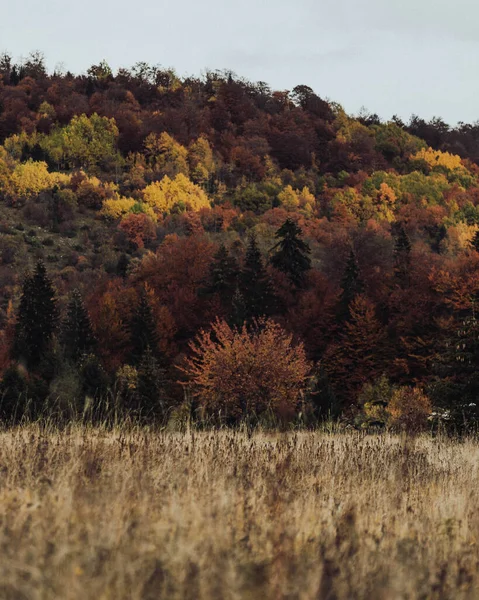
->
[[240, 235, 274, 321]]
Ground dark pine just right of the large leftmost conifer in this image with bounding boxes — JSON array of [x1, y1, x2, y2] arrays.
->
[[61, 290, 96, 362]]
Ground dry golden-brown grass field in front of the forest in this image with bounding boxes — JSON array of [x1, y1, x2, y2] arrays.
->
[[0, 426, 479, 600]]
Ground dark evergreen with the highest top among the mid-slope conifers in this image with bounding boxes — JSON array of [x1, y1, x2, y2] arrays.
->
[[271, 219, 311, 288]]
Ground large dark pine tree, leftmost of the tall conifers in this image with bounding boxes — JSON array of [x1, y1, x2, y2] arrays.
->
[[12, 261, 58, 368]]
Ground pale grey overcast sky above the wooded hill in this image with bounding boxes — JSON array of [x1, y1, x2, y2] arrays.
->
[[0, 0, 479, 124]]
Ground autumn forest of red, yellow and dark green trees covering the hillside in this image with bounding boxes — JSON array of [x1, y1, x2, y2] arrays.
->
[[0, 52, 479, 431]]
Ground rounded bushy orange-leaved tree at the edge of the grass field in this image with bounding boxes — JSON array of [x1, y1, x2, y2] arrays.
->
[[182, 319, 310, 423]]
